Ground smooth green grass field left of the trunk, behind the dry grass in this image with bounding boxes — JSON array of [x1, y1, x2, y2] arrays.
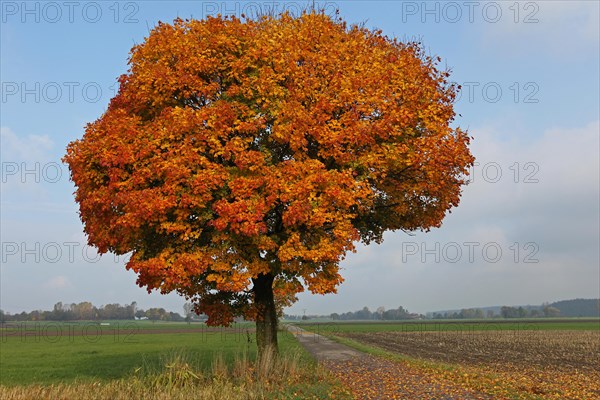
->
[[0, 321, 256, 385]]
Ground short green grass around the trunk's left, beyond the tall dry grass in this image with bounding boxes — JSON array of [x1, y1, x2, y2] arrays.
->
[[0, 321, 298, 386]]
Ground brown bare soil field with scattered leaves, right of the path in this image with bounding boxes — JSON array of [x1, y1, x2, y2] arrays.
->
[[339, 330, 600, 400]]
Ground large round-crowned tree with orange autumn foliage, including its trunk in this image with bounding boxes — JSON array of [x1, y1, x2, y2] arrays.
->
[[64, 11, 474, 354]]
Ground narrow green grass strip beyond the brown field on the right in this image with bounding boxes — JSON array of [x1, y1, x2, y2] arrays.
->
[[294, 318, 600, 334]]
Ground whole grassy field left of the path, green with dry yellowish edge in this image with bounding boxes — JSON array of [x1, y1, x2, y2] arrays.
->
[[0, 321, 345, 399]]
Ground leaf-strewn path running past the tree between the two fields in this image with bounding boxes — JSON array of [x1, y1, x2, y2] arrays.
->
[[288, 325, 493, 400]]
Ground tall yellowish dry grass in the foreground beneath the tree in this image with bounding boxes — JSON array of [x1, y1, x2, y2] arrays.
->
[[0, 352, 344, 400]]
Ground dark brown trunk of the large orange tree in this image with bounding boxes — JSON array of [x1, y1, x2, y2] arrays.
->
[[252, 274, 279, 359]]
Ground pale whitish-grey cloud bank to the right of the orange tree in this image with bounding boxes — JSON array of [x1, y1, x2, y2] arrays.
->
[[289, 121, 600, 314]]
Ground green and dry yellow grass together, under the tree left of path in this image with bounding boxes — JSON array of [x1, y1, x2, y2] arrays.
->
[[0, 326, 352, 400]]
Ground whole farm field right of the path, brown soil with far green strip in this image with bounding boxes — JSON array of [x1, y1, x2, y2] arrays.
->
[[305, 320, 600, 399]]
